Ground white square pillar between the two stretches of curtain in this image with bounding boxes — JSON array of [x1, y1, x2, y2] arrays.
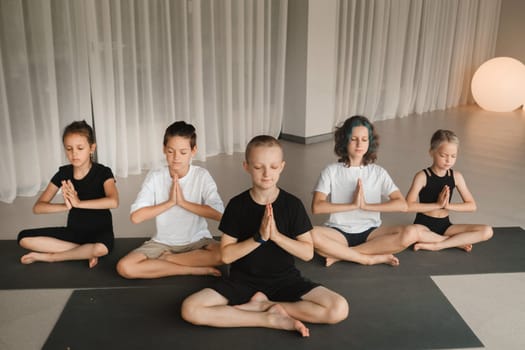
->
[[283, 0, 337, 143]]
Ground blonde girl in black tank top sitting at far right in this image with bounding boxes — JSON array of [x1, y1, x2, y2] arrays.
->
[[407, 130, 492, 252]]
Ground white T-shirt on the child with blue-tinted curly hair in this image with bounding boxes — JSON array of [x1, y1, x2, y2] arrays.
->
[[314, 163, 398, 233]]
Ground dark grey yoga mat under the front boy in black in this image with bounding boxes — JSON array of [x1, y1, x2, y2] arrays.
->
[[44, 276, 482, 350]]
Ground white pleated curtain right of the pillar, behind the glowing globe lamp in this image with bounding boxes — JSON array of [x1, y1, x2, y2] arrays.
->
[[335, 0, 501, 124]]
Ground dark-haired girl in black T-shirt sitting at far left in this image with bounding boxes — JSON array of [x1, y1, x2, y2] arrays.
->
[[18, 121, 118, 267]]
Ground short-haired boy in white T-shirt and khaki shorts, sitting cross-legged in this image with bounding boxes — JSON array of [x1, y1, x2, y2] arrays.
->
[[117, 121, 224, 278]]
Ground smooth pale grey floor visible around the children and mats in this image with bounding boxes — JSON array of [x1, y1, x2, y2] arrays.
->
[[0, 106, 525, 349]]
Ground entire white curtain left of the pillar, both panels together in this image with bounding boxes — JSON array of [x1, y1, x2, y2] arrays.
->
[[0, 0, 287, 202]]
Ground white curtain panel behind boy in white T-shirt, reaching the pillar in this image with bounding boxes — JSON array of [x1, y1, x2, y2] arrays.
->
[[86, 0, 287, 176]]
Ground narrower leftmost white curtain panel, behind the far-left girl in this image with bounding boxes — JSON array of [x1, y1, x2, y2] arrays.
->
[[0, 0, 91, 202]]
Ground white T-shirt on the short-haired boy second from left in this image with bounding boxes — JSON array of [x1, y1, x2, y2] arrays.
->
[[131, 165, 224, 245]]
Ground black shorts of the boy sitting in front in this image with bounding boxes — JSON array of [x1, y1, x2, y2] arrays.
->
[[210, 275, 320, 305]]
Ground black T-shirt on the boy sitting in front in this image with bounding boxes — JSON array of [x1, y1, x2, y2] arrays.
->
[[219, 189, 312, 282]]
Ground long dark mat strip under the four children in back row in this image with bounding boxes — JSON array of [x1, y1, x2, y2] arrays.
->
[[0, 227, 525, 289]]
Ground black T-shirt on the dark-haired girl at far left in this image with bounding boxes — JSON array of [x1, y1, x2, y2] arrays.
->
[[51, 163, 114, 231]]
